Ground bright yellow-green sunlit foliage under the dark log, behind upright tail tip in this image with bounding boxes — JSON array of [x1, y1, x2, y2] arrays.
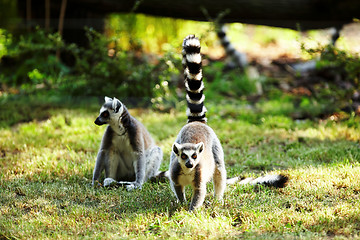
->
[[106, 13, 216, 54]]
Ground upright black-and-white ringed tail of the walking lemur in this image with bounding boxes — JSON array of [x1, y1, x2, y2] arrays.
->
[[182, 35, 207, 123]]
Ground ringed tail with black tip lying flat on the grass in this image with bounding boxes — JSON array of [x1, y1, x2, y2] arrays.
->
[[226, 174, 289, 188]]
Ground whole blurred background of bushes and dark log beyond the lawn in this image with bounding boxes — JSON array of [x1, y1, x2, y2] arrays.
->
[[0, 0, 360, 126]]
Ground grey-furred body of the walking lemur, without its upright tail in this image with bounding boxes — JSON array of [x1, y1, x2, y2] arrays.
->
[[169, 122, 226, 211]]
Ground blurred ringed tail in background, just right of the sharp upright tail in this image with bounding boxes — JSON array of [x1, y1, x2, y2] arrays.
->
[[217, 24, 248, 69]]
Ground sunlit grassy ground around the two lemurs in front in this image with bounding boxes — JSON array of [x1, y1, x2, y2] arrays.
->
[[0, 95, 360, 239]]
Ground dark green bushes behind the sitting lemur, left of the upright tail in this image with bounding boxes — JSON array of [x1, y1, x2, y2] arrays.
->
[[0, 29, 179, 98]]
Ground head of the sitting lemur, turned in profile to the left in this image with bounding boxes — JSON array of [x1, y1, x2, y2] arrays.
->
[[95, 97, 124, 126]]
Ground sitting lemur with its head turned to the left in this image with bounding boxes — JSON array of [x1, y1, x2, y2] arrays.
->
[[92, 97, 163, 190]]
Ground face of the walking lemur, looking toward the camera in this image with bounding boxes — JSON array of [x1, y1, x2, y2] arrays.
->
[[173, 142, 204, 169]]
